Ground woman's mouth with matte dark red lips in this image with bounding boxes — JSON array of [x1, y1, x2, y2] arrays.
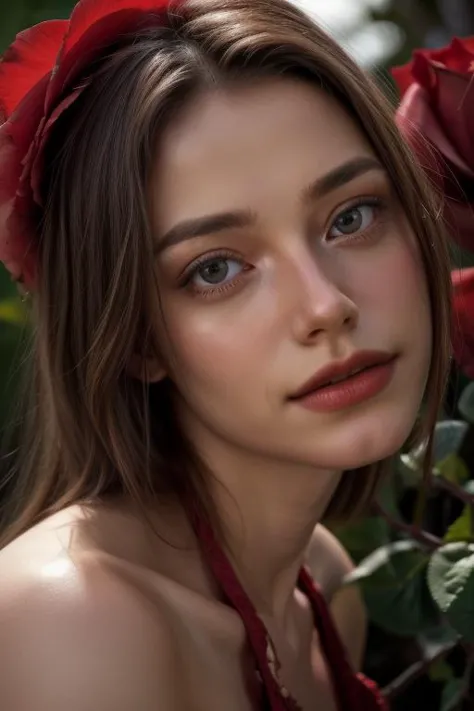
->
[[289, 351, 397, 401]]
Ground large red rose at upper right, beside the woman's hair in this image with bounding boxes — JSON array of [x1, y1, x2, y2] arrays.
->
[[392, 37, 474, 251]]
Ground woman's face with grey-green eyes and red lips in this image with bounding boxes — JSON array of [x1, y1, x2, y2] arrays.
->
[[151, 79, 431, 470]]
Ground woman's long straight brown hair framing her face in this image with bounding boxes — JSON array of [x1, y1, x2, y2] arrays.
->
[[0, 0, 450, 543]]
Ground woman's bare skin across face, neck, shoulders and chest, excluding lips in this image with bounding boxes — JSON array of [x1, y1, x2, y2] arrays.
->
[[0, 79, 431, 711]]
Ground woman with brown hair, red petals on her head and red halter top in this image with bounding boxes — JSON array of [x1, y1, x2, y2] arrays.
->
[[0, 0, 449, 711]]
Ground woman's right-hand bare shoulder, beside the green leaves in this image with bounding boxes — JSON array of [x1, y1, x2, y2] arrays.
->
[[307, 524, 367, 669]]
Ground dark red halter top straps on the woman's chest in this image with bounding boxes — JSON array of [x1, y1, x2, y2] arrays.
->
[[193, 515, 388, 711]]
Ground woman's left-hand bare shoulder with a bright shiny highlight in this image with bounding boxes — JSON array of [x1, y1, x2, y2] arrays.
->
[[0, 508, 186, 711]]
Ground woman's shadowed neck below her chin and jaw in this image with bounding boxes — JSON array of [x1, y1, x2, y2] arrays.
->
[[188, 426, 340, 625]]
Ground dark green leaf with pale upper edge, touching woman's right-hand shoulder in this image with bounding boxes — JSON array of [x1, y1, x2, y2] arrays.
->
[[346, 540, 439, 637]]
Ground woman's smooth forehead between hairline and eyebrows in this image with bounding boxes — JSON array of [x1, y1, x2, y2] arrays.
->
[[152, 78, 373, 230]]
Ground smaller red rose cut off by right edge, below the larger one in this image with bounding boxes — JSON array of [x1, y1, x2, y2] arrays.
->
[[451, 267, 474, 378]]
